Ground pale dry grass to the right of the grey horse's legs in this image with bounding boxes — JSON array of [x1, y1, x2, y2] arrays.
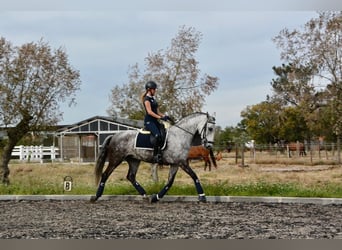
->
[[208, 151, 342, 186]]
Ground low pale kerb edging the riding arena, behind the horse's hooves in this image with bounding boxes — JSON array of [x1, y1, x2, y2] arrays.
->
[[0, 195, 342, 205]]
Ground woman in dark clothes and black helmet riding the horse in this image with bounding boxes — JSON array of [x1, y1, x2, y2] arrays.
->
[[141, 81, 169, 164]]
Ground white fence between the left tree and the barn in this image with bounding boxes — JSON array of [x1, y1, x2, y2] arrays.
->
[[12, 146, 59, 162]]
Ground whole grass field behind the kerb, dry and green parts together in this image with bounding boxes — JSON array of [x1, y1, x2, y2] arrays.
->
[[0, 151, 342, 198]]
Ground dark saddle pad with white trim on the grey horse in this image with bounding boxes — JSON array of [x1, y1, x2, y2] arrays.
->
[[134, 123, 168, 150]]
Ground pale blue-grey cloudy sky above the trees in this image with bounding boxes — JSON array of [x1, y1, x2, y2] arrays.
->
[[0, 0, 340, 128]]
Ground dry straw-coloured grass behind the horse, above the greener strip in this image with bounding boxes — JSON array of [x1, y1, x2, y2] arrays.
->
[[4, 149, 342, 192]]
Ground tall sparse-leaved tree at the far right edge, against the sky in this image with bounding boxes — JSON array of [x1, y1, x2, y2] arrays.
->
[[273, 11, 342, 135]]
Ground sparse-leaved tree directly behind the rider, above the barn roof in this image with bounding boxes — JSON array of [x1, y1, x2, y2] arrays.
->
[[107, 26, 218, 119]]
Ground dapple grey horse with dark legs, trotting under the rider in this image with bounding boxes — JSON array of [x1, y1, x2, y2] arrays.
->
[[91, 112, 215, 202]]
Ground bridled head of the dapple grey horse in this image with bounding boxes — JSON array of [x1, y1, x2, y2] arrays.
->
[[198, 113, 215, 148]]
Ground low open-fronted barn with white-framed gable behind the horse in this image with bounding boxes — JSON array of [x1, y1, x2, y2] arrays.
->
[[55, 116, 143, 162]]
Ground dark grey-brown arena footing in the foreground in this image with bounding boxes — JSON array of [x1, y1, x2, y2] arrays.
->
[[0, 195, 342, 239]]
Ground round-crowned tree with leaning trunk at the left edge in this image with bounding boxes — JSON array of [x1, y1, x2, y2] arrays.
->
[[0, 38, 81, 184]]
